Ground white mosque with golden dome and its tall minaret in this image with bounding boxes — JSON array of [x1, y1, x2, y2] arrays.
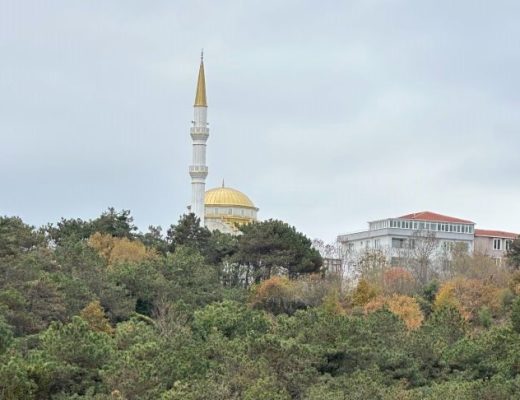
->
[[188, 54, 258, 234]]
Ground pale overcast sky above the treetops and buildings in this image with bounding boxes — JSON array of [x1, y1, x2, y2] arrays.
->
[[0, 0, 520, 240]]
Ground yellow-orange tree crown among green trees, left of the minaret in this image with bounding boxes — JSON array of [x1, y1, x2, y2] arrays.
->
[[88, 232, 153, 265]]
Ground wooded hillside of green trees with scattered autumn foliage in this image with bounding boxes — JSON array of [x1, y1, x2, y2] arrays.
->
[[0, 208, 520, 400]]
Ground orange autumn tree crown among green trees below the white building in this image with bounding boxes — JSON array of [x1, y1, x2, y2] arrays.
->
[[365, 294, 424, 329]]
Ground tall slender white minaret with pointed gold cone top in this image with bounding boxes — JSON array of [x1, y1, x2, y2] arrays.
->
[[190, 53, 209, 226]]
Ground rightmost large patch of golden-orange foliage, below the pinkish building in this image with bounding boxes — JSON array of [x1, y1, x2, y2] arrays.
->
[[435, 278, 500, 320]]
